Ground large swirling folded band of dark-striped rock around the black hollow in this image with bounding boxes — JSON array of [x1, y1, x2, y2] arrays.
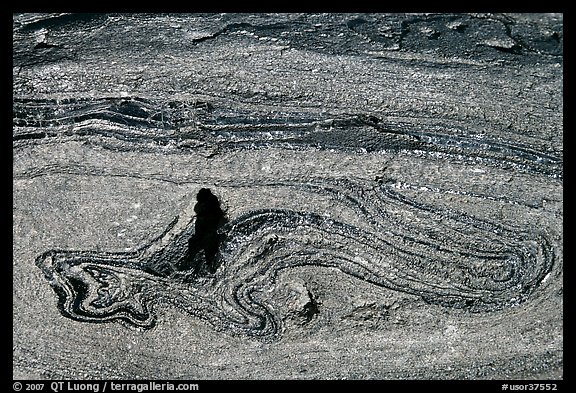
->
[[37, 179, 554, 337]]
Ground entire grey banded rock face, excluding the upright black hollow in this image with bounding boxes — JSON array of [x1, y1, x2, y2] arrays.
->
[[13, 14, 563, 379]]
